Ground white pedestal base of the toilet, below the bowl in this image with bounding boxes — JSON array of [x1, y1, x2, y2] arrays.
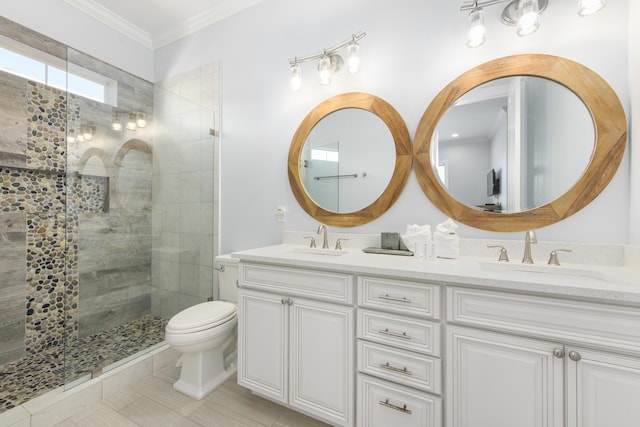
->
[[173, 348, 237, 400]]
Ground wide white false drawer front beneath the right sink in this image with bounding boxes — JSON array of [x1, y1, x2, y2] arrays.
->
[[447, 287, 640, 354]]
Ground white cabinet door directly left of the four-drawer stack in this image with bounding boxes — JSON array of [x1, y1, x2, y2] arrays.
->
[[289, 298, 355, 426]]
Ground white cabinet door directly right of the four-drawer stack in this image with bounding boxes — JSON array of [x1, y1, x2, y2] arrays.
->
[[446, 326, 564, 427]]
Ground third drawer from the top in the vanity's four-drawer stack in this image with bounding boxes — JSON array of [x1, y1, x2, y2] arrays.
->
[[358, 341, 442, 394]]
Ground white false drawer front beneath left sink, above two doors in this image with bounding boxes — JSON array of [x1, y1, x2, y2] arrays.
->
[[238, 263, 355, 304]]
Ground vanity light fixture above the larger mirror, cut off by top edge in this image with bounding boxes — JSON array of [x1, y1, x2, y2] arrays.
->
[[460, 0, 607, 47]]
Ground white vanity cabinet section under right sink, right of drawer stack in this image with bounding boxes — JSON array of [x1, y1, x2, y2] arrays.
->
[[446, 287, 640, 427]]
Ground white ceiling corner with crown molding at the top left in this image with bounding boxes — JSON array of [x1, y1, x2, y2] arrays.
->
[[65, 0, 263, 49]]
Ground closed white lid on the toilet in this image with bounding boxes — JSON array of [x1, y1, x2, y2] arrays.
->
[[166, 301, 237, 333]]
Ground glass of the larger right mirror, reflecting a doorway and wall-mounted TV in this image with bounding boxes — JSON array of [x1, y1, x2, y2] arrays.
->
[[431, 76, 595, 212]]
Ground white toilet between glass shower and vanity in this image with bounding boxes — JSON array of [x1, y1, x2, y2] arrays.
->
[[165, 256, 238, 400]]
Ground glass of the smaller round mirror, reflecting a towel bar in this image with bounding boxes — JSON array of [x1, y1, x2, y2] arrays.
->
[[300, 108, 395, 213]]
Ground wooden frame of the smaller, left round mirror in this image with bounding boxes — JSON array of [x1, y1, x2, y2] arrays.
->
[[287, 92, 412, 227]]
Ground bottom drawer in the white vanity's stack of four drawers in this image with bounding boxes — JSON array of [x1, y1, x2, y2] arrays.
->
[[356, 374, 442, 427]]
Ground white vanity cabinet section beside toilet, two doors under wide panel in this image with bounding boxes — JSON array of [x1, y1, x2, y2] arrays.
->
[[238, 263, 355, 426]]
